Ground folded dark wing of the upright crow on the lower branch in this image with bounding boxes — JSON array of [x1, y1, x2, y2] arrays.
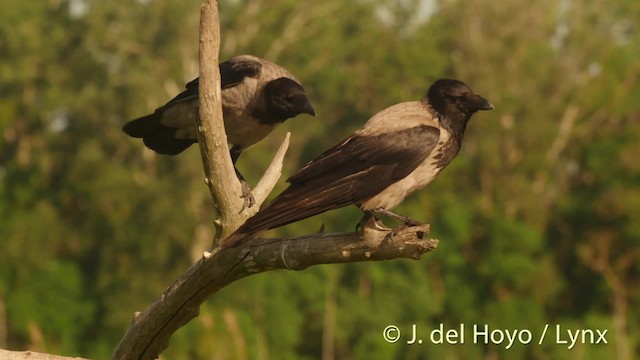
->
[[225, 125, 440, 246]]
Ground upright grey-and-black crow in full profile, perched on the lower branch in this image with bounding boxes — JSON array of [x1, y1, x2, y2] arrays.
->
[[221, 79, 493, 247]]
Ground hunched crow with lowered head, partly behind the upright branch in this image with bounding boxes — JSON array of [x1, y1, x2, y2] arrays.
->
[[122, 55, 315, 206]]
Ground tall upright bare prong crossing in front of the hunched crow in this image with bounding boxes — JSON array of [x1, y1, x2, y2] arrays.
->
[[196, 0, 246, 240]]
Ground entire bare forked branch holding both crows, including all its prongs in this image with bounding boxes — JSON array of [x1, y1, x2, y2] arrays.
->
[[112, 0, 438, 359]]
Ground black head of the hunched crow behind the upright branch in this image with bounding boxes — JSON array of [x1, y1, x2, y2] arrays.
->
[[264, 77, 316, 121]]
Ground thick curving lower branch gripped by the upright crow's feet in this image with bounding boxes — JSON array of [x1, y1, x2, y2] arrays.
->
[[112, 220, 438, 359]]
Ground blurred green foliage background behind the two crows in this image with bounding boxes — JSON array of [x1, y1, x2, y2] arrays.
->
[[0, 0, 640, 359]]
